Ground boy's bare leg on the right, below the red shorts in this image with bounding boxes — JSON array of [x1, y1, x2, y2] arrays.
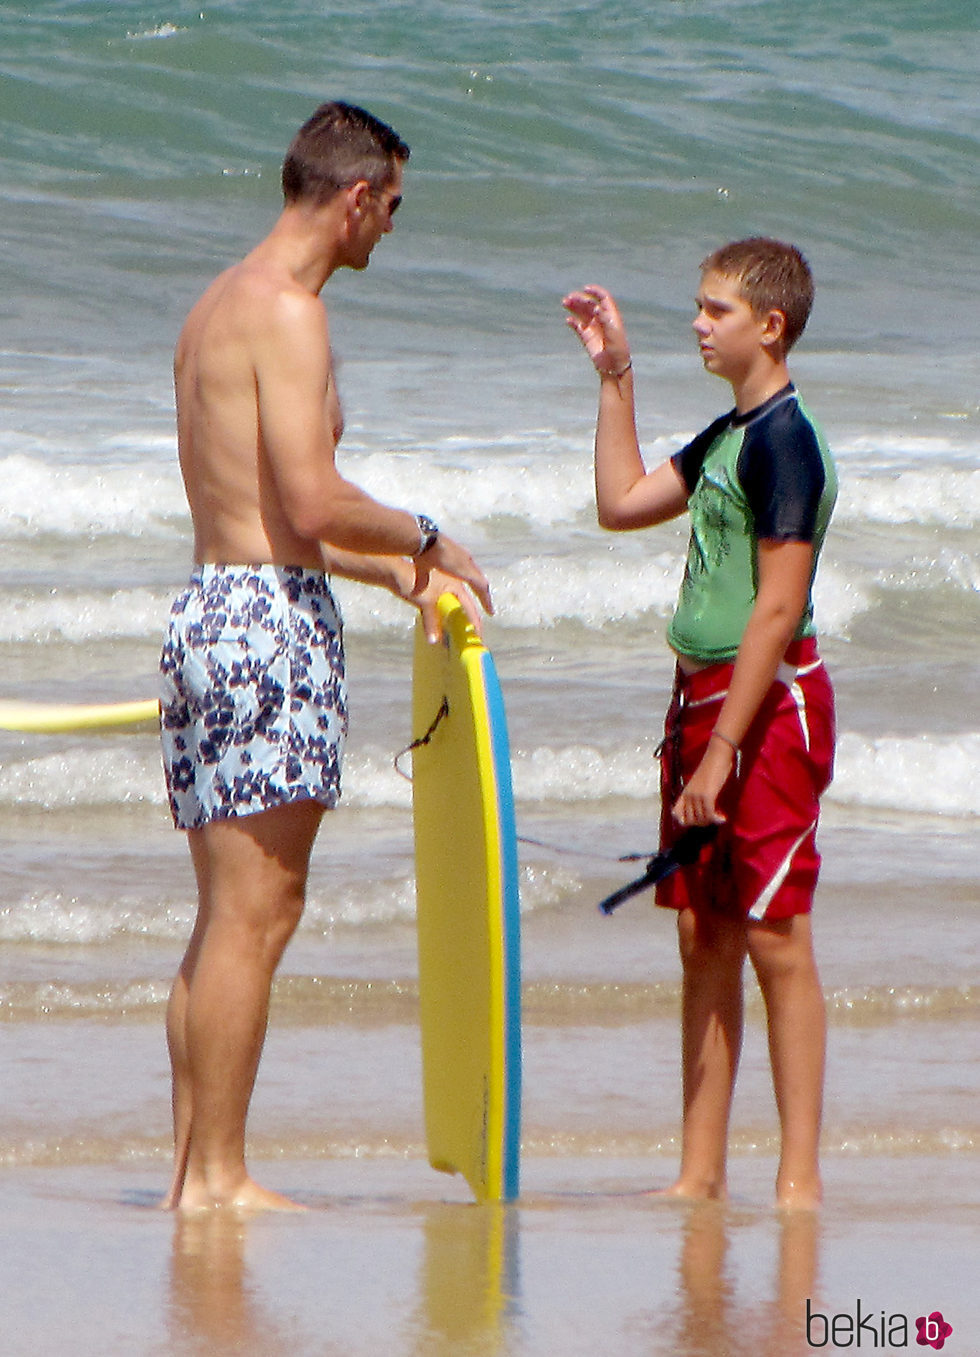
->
[[748, 915, 827, 1209]]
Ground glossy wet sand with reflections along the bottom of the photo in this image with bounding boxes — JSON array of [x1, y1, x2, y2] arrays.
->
[[0, 1155, 980, 1357]]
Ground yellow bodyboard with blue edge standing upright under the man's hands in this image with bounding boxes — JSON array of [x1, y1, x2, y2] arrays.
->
[[413, 594, 521, 1201]]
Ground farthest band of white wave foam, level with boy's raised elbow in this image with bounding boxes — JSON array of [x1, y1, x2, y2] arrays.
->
[[0, 432, 980, 539]]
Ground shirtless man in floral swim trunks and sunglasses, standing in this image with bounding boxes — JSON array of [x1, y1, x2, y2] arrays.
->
[[160, 103, 491, 1210]]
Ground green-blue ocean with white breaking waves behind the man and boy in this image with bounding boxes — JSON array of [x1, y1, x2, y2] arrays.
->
[[0, 0, 980, 1353]]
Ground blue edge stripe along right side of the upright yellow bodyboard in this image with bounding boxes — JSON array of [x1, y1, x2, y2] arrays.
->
[[480, 650, 521, 1201]]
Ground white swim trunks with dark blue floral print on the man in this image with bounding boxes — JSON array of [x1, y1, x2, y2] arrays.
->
[[160, 565, 347, 829]]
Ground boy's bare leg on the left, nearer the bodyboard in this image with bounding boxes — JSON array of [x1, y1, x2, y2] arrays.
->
[[668, 909, 745, 1198]]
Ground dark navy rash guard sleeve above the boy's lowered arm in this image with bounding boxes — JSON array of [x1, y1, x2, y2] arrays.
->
[[738, 400, 827, 541]]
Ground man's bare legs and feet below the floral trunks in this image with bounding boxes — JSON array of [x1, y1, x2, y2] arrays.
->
[[164, 801, 323, 1210]]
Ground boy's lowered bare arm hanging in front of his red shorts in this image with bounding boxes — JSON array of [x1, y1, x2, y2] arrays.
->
[[673, 541, 813, 826]]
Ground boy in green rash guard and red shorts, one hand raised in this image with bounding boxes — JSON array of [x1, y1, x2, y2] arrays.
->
[[565, 239, 836, 1208]]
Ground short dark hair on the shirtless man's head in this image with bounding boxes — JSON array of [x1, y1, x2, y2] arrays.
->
[[282, 100, 410, 204]]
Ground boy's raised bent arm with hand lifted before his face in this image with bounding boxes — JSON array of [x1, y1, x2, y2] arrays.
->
[[563, 286, 688, 532]]
